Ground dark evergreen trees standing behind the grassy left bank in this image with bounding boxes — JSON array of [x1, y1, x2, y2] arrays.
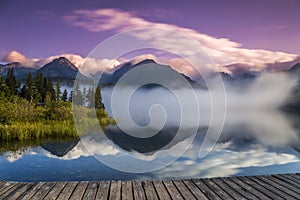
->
[[0, 68, 104, 109]]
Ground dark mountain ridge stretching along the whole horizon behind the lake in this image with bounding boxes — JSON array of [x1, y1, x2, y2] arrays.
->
[[0, 56, 300, 85]]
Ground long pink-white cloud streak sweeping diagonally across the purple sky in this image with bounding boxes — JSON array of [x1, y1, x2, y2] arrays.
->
[[64, 9, 299, 74]]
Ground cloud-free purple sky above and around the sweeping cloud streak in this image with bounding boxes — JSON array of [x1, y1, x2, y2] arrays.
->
[[0, 0, 300, 57]]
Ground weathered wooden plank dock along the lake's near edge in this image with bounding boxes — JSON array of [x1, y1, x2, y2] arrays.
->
[[0, 174, 300, 200]]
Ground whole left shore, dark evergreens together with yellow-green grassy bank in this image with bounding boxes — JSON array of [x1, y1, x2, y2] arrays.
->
[[0, 69, 116, 143]]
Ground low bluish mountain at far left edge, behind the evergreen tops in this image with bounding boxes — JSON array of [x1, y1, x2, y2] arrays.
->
[[0, 62, 37, 79]]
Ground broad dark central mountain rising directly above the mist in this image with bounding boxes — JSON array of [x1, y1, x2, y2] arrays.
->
[[95, 59, 197, 87]]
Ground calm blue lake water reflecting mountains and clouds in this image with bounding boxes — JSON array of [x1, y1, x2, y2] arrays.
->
[[0, 86, 300, 181]]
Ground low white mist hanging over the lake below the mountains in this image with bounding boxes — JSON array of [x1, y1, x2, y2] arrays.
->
[[102, 73, 300, 149]]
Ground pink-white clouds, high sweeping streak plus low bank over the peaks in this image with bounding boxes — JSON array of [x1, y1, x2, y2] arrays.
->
[[2, 9, 300, 78]]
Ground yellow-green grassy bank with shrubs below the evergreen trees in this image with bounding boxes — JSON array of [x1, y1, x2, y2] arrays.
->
[[0, 97, 115, 142]]
